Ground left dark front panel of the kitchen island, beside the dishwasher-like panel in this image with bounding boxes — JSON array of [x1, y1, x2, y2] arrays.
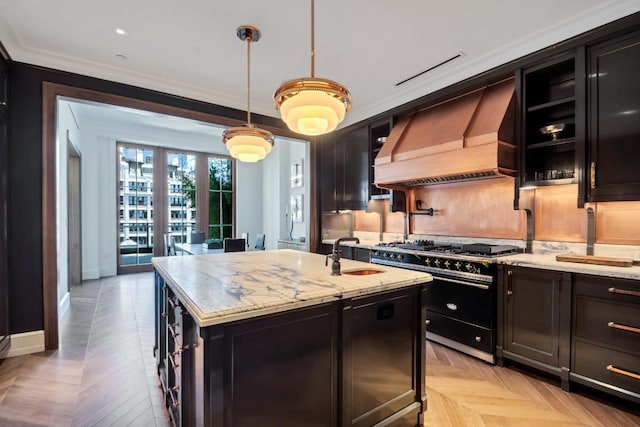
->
[[216, 304, 338, 427]]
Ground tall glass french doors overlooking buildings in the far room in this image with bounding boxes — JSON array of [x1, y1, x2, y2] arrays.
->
[[117, 143, 235, 274]]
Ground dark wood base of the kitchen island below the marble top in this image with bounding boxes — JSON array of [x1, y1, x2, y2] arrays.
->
[[154, 271, 426, 427]]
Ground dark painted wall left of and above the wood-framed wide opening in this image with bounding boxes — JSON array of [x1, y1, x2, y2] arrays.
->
[[7, 63, 283, 334]]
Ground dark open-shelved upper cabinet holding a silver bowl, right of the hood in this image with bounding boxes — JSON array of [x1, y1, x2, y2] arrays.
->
[[521, 55, 579, 185]]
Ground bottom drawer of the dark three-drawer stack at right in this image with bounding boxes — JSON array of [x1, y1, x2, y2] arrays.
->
[[572, 340, 640, 393]]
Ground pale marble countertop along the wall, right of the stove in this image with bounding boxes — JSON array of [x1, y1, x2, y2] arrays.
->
[[498, 254, 640, 280]]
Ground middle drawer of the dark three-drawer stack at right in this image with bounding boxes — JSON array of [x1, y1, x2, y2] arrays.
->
[[575, 297, 640, 353]]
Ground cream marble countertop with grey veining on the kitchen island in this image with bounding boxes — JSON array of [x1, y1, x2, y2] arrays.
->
[[152, 249, 432, 327]]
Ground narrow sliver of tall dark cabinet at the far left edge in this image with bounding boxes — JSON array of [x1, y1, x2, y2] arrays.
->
[[0, 59, 9, 351]]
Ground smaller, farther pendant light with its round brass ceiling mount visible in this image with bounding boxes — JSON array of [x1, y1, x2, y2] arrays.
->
[[222, 25, 274, 163]]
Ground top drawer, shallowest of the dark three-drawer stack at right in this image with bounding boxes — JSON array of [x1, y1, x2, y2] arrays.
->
[[574, 275, 640, 305]]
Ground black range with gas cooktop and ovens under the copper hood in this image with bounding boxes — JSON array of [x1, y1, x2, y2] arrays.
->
[[371, 240, 521, 363]]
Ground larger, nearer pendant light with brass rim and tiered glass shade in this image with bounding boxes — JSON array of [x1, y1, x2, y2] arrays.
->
[[273, 0, 351, 136]]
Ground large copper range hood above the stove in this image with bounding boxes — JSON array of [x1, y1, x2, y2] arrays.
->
[[374, 79, 516, 188]]
